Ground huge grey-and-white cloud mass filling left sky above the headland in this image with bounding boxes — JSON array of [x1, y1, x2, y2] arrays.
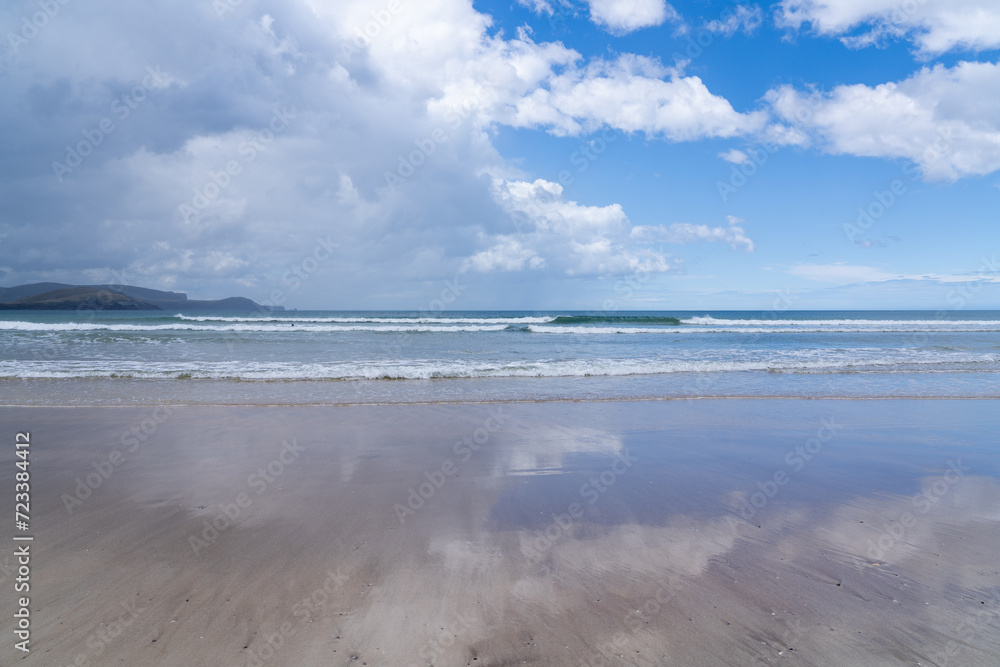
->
[[0, 0, 762, 307]]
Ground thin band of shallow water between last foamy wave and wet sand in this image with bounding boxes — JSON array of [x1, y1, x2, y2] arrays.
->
[[0, 371, 1000, 407]]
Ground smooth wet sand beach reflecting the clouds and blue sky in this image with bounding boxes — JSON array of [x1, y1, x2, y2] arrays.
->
[[0, 400, 1000, 666]]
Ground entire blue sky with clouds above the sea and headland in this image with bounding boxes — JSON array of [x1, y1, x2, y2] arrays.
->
[[0, 0, 1000, 311]]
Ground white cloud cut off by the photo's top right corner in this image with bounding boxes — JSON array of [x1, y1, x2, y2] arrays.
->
[[776, 0, 1000, 54]]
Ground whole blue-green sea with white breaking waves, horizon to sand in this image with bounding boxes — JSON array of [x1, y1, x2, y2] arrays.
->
[[0, 310, 1000, 405]]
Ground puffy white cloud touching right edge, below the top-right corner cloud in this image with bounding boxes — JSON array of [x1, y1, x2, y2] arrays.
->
[[765, 62, 1000, 180]]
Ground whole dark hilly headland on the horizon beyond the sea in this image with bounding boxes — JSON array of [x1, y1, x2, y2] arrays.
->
[[0, 283, 284, 311]]
